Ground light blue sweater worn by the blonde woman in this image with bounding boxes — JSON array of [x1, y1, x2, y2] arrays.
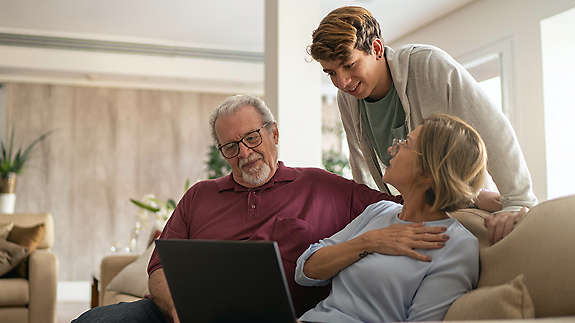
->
[[295, 201, 479, 322]]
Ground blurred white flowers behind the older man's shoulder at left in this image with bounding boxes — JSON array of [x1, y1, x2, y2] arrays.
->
[[128, 179, 191, 252]]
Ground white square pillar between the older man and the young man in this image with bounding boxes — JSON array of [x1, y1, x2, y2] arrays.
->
[[264, 0, 322, 167]]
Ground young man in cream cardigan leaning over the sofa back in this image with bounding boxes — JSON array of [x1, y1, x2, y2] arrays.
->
[[309, 7, 537, 243]]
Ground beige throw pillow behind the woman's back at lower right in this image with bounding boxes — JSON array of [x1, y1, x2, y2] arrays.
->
[[444, 274, 535, 321]]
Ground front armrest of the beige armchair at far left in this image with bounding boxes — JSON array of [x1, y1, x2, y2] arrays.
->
[[28, 249, 58, 323]]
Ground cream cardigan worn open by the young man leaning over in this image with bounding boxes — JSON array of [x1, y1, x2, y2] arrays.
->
[[337, 45, 537, 211]]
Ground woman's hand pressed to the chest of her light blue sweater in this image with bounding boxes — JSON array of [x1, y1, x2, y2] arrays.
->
[[365, 223, 449, 261]]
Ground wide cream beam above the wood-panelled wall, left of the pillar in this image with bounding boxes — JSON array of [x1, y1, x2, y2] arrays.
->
[[0, 45, 263, 95]]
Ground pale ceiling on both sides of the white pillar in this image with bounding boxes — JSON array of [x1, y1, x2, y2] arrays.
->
[[0, 0, 473, 52]]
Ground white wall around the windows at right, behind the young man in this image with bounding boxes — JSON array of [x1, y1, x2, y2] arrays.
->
[[390, 0, 575, 201]]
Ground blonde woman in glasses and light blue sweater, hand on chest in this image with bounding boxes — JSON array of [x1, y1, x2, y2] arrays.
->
[[296, 115, 487, 322]]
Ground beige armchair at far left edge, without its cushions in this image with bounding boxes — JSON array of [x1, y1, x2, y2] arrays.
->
[[0, 213, 58, 323]]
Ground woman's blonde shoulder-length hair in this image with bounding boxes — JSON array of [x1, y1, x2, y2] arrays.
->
[[417, 114, 487, 211]]
